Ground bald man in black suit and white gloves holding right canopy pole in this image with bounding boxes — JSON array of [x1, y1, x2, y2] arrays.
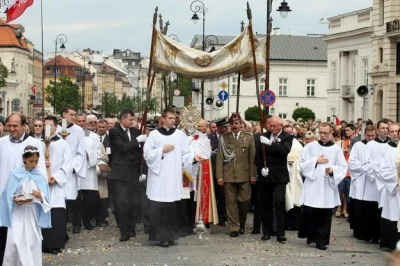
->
[[254, 116, 293, 243]]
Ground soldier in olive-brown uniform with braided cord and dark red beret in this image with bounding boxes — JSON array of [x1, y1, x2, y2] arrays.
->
[[217, 114, 256, 237]]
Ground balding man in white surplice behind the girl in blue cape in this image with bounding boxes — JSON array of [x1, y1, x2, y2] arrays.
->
[[0, 113, 46, 264]]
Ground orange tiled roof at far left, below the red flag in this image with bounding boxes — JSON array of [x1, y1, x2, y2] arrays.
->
[[0, 18, 29, 50]]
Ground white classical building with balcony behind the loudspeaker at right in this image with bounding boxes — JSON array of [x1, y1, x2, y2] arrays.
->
[[323, 7, 373, 121]]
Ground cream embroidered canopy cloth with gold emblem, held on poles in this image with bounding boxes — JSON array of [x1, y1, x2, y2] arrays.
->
[[153, 27, 265, 79]]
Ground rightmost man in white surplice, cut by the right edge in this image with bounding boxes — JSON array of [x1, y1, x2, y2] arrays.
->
[[377, 123, 400, 251]]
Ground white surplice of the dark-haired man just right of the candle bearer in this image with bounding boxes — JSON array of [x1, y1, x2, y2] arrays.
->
[[57, 124, 86, 200]]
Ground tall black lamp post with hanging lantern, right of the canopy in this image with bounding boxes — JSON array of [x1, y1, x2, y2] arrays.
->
[[264, 0, 292, 115]]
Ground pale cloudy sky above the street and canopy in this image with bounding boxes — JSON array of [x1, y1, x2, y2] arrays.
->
[[2, 0, 372, 56]]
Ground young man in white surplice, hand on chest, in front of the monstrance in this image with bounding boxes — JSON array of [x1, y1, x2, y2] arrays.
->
[[143, 109, 201, 247]]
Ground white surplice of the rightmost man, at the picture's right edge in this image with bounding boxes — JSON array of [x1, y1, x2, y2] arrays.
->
[[377, 142, 400, 222]]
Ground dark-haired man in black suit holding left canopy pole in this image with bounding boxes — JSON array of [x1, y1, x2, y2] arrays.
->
[[109, 110, 147, 241]]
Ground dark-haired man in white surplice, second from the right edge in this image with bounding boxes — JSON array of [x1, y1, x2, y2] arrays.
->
[[362, 120, 390, 244]]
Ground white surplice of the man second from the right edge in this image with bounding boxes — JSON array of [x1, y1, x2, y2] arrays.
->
[[362, 140, 386, 208]]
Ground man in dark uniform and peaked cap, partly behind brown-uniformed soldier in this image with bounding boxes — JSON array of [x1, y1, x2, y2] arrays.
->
[[208, 117, 229, 226]]
